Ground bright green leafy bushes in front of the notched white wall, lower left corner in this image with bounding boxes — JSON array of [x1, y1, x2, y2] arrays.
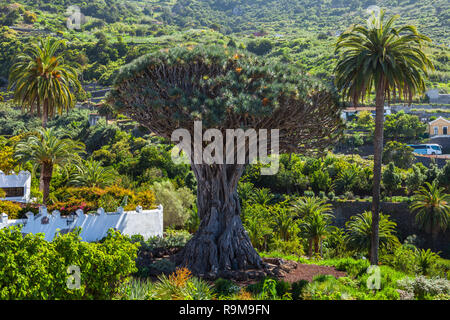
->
[[0, 227, 137, 300]]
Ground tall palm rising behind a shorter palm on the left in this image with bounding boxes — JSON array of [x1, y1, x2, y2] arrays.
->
[[8, 37, 81, 128]]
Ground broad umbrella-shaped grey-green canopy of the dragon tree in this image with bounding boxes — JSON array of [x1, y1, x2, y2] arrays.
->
[[109, 46, 341, 154]]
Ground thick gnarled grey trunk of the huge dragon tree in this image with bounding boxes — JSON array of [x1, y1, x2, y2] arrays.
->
[[179, 164, 263, 275]]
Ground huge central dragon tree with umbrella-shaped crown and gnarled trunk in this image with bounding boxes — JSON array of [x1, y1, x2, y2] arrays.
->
[[108, 46, 342, 275]]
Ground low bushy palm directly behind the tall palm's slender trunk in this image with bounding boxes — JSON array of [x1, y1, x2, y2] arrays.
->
[[345, 211, 399, 261]]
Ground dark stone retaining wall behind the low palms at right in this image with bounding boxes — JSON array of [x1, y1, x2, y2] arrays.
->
[[332, 201, 450, 259]]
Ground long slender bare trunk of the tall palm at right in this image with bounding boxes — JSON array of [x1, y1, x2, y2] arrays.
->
[[370, 77, 385, 265]]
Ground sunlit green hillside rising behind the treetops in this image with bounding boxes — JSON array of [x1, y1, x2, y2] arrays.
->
[[0, 0, 450, 92]]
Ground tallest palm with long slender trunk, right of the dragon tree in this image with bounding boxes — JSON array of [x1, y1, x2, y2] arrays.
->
[[335, 11, 434, 264]]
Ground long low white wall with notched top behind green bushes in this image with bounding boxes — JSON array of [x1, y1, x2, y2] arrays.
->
[[0, 205, 163, 242]]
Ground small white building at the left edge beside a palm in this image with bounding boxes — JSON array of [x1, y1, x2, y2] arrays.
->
[[0, 171, 31, 203]]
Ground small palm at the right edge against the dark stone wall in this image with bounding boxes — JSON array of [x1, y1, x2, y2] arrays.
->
[[410, 181, 450, 245]]
